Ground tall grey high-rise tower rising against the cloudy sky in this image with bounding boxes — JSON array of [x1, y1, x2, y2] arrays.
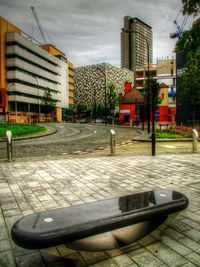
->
[[121, 16, 153, 71]]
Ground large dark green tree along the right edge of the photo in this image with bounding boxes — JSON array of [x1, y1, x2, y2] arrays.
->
[[176, 4, 200, 125]]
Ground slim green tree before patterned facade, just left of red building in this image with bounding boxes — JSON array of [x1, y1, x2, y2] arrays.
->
[[107, 83, 119, 115]]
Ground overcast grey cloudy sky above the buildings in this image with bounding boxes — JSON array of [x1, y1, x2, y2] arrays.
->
[[0, 0, 192, 66]]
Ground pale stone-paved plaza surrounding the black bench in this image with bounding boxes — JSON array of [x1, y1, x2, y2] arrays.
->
[[0, 154, 200, 267]]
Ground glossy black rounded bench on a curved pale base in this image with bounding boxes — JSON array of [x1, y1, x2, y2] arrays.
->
[[11, 189, 188, 251]]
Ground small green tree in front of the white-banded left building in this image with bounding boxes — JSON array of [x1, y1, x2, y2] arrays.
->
[[42, 88, 57, 121]]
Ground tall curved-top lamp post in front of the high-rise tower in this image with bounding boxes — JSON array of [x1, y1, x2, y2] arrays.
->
[[122, 29, 150, 133]]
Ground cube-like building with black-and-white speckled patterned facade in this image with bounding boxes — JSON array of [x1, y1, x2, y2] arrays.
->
[[75, 63, 134, 107]]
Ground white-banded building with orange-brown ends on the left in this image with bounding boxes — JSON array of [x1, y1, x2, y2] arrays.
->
[[0, 17, 73, 123]]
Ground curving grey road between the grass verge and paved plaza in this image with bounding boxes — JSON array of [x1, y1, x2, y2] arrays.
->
[[0, 123, 138, 159]]
